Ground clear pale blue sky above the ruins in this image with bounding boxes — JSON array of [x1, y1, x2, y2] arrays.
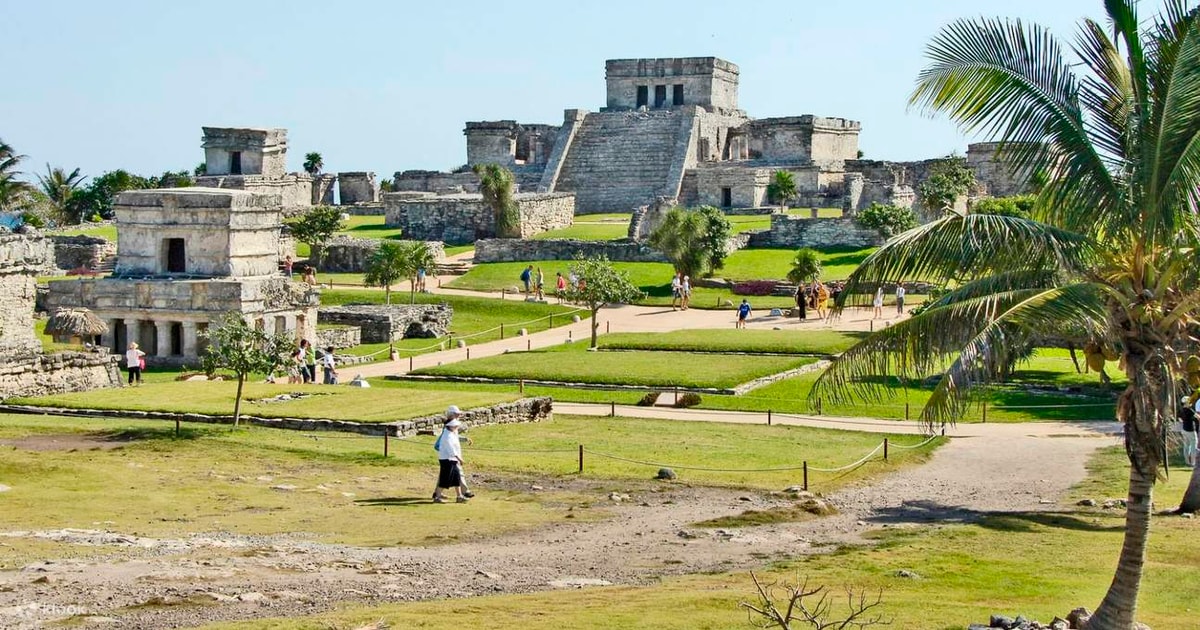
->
[[0, 0, 1108, 178]]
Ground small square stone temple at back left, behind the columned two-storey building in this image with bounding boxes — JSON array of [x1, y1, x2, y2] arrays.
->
[[196, 127, 337, 214]]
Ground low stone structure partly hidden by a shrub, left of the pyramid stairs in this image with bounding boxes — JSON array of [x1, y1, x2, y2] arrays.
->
[[383, 192, 575, 245]]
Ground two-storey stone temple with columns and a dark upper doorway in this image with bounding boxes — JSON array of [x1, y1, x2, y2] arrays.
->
[[46, 187, 318, 365]]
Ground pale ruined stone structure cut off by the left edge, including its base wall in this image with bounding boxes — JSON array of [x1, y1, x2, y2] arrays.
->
[[0, 234, 121, 398]]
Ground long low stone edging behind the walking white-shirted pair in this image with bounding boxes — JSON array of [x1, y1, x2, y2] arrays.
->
[[0, 396, 553, 436]]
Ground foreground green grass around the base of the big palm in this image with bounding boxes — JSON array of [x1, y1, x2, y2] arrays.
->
[[209, 448, 1200, 630]]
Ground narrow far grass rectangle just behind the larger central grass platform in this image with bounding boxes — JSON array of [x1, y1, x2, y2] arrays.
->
[[598, 329, 864, 354]]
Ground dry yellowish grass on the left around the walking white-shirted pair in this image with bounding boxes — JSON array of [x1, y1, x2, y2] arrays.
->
[[0, 414, 578, 547]]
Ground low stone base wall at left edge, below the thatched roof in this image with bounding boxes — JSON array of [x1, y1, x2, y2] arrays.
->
[[0, 352, 121, 398]]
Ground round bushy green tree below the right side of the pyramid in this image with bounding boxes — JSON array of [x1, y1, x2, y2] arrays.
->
[[649, 205, 731, 277]]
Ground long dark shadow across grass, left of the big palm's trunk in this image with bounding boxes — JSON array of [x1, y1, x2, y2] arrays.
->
[[865, 500, 1123, 534]]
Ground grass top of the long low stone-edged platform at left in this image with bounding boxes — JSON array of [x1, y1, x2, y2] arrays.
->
[[10, 380, 518, 422]]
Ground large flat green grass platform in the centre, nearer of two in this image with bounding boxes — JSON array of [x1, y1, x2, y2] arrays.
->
[[415, 343, 812, 388]]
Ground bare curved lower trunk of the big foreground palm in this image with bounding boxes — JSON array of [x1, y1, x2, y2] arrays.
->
[[1086, 453, 1154, 630]]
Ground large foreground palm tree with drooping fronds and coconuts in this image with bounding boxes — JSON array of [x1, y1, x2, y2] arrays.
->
[[812, 0, 1200, 630]]
